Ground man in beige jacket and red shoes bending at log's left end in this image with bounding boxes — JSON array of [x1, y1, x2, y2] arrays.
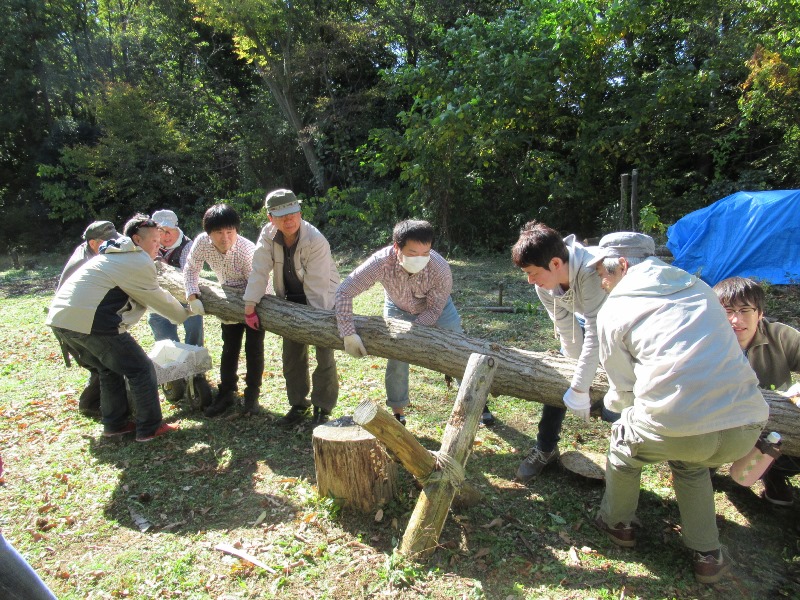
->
[[47, 215, 191, 442]]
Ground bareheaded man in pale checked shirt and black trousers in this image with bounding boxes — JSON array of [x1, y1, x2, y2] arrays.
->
[[183, 204, 264, 417]]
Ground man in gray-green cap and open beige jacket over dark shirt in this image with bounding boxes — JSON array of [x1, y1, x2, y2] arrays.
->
[[243, 189, 339, 426]]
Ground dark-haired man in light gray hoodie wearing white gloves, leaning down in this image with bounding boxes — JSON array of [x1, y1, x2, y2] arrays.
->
[[511, 221, 606, 483]]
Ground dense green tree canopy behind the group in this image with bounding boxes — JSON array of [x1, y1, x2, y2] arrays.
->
[[0, 0, 800, 251]]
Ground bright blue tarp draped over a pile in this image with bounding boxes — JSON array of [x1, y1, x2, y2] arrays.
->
[[667, 190, 800, 285]]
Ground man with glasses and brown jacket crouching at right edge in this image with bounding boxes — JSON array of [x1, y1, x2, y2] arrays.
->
[[714, 277, 800, 506]]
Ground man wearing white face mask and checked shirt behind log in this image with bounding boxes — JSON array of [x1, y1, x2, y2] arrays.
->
[[336, 220, 494, 425]]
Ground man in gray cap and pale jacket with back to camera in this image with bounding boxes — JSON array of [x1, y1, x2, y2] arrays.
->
[[591, 232, 769, 583]]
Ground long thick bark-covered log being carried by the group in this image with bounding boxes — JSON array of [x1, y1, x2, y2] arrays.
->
[[159, 265, 800, 456]]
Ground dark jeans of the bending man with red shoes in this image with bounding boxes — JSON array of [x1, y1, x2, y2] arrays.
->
[[53, 327, 161, 437]]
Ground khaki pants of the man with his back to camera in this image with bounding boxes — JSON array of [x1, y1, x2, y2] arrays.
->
[[600, 409, 764, 552]]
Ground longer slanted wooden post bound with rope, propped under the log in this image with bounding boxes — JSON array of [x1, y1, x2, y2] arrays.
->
[[400, 354, 497, 558]]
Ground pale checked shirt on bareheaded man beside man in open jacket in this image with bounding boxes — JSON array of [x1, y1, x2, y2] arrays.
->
[[183, 233, 256, 298]]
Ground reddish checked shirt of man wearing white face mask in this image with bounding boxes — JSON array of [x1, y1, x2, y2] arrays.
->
[[336, 246, 453, 337]]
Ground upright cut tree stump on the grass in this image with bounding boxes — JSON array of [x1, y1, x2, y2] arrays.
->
[[312, 417, 397, 513]]
